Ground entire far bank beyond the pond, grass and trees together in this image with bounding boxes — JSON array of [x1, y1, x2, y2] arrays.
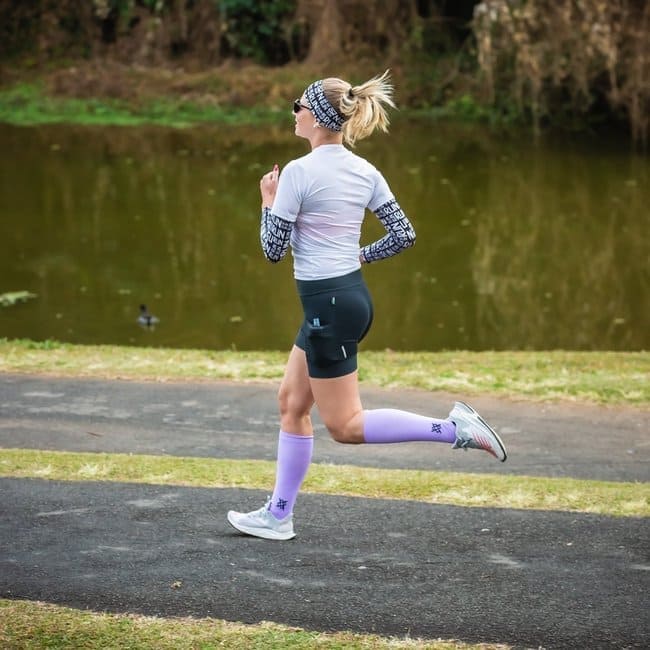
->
[[0, 0, 650, 139]]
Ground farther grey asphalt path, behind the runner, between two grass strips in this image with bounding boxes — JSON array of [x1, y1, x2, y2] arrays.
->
[[0, 374, 650, 481]]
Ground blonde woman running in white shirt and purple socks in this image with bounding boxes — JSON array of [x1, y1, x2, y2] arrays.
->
[[228, 71, 506, 540]]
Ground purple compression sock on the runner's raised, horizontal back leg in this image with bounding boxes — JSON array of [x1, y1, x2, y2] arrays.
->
[[363, 409, 456, 443]]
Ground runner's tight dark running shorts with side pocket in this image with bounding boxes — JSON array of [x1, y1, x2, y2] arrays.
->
[[296, 270, 373, 379]]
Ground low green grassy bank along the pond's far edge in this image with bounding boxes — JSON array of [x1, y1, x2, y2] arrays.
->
[[0, 78, 502, 128]]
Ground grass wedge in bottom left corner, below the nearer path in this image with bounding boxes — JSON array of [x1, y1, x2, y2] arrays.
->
[[0, 599, 510, 650]]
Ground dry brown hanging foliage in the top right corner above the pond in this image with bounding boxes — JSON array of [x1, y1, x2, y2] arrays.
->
[[472, 0, 650, 144]]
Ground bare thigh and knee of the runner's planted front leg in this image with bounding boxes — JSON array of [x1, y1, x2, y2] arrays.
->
[[278, 345, 314, 436]]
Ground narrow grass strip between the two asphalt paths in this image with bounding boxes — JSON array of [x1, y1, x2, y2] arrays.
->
[[0, 449, 650, 517]]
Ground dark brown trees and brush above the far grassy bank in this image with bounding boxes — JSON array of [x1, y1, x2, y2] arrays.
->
[[0, 0, 650, 139]]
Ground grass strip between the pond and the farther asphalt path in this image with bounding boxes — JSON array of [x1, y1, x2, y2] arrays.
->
[[0, 339, 650, 409]]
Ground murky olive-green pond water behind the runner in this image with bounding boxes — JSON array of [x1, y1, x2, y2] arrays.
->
[[0, 121, 650, 350]]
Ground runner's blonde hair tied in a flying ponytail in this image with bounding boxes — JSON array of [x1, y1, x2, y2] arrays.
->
[[323, 70, 395, 147]]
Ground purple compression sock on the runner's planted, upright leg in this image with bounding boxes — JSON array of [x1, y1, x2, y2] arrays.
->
[[269, 431, 314, 519]]
